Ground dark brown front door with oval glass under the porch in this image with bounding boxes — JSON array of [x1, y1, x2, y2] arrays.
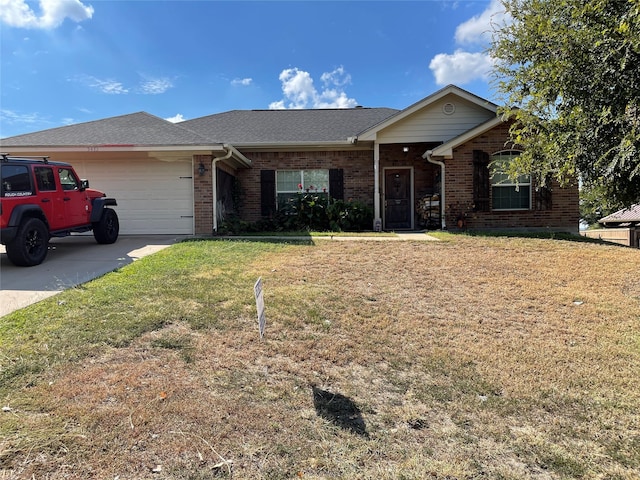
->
[[384, 168, 411, 230]]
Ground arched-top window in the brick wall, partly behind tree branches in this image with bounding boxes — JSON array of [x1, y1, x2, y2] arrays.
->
[[491, 150, 531, 210]]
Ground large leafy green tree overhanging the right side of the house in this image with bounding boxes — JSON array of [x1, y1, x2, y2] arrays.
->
[[490, 0, 640, 213]]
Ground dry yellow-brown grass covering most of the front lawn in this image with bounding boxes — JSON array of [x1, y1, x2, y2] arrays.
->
[[0, 237, 640, 480]]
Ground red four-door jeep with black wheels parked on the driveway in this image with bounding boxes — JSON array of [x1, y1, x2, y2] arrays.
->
[[0, 154, 120, 266]]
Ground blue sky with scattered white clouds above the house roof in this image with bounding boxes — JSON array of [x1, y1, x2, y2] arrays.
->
[[0, 0, 510, 138]]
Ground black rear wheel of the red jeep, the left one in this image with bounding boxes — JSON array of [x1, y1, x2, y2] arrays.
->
[[7, 218, 49, 267]]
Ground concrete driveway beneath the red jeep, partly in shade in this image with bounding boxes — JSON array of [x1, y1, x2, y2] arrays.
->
[[0, 235, 187, 317]]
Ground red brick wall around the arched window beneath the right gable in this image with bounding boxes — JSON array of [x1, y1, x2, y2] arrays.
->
[[444, 124, 580, 233]]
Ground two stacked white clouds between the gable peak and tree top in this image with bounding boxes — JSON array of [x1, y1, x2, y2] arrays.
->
[[429, 0, 511, 85]]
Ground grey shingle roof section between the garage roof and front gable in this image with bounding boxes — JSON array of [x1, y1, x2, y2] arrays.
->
[[178, 107, 398, 147]]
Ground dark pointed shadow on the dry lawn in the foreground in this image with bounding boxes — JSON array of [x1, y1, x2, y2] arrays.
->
[[311, 385, 369, 438]]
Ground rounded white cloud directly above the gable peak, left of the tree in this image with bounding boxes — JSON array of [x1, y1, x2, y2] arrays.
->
[[429, 50, 493, 85]]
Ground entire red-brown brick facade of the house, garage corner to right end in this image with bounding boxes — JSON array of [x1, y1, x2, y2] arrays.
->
[[193, 124, 579, 234]]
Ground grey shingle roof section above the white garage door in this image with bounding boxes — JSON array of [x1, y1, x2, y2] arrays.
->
[[0, 112, 211, 147]]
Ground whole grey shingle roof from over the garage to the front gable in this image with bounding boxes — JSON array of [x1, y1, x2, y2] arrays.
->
[[0, 108, 398, 147]]
